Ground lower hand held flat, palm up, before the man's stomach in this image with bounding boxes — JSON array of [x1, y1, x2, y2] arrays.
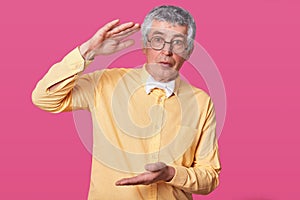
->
[[115, 162, 175, 186]]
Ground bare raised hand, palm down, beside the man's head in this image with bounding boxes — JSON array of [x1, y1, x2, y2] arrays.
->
[[79, 19, 140, 60]]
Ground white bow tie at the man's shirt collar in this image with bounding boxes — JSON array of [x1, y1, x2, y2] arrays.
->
[[145, 76, 175, 98]]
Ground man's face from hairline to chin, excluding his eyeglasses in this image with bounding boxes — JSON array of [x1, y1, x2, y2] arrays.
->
[[143, 20, 188, 82]]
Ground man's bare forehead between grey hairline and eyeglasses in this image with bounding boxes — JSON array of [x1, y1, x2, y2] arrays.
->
[[149, 20, 187, 37]]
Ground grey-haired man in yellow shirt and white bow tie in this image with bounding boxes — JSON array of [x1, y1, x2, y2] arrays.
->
[[32, 6, 221, 200]]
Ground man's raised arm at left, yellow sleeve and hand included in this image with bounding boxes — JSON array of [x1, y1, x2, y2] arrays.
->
[[32, 20, 139, 113]]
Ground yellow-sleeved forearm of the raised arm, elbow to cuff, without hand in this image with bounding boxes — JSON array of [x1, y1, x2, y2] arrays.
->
[[32, 49, 91, 113]]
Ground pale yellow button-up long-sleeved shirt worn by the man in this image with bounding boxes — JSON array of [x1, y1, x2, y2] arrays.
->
[[32, 48, 221, 200]]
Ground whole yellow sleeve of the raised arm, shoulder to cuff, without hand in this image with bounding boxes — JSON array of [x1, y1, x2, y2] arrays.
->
[[32, 48, 99, 113]]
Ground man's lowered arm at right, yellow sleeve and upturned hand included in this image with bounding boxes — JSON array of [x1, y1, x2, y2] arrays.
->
[[116, 101, 221, 194]]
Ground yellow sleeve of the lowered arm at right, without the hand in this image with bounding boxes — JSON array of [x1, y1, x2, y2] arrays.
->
[[167, 100, 221, 194]]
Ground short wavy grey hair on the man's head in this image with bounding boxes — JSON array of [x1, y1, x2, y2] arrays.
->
[[141, 5, 196, 52]]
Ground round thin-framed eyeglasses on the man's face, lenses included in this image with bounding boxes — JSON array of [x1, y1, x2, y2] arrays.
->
[[148, 36, 187, 54]]
